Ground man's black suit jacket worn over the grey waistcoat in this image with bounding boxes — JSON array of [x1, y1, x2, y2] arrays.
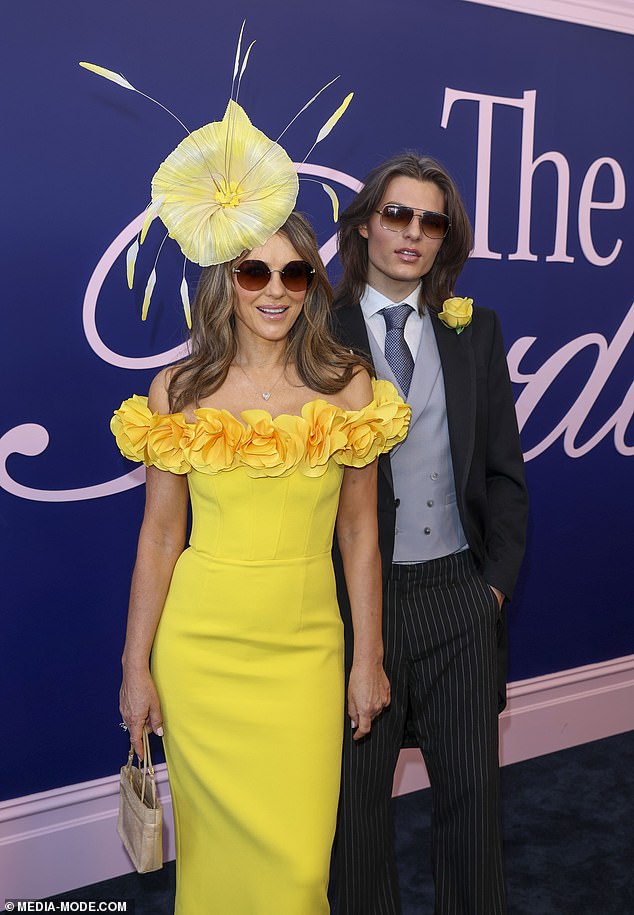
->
[[332, 300, 528, 709]]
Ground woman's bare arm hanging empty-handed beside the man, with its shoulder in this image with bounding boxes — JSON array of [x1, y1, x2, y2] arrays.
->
[[337, 372, 390, 740]]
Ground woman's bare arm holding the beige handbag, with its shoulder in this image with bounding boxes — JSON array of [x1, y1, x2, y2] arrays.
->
[[119, 373, 188, 756]]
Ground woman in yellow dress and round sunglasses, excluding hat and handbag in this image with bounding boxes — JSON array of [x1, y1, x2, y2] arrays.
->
[[112, 213, 409, 915]]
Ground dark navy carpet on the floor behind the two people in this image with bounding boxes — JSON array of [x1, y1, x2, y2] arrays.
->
[[44, 731, 634, 915]]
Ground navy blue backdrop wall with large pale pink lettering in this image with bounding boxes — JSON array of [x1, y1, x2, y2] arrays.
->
[[0, 0, 634, 798]]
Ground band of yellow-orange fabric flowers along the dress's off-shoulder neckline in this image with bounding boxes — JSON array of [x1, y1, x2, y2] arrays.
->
[[110, 380, 411, 477]]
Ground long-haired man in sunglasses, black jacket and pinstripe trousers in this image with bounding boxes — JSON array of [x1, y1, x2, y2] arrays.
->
[[333, 154, 527, 915]]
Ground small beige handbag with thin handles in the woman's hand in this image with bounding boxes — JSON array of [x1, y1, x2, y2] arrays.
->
[[117, 728, 163, 874]]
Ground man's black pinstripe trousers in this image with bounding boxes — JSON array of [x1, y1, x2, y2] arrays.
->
[[332, 550, 506, 915]]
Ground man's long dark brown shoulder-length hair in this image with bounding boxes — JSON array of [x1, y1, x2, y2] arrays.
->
[[335, 152, 473, 311]]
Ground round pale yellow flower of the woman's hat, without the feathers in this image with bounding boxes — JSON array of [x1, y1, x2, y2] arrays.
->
[[152, 100, 299, 267]]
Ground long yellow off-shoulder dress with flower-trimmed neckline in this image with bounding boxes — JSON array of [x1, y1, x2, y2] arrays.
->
[[111, 381, 409, 915]]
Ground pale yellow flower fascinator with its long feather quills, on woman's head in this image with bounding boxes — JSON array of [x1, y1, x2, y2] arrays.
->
[[80, 22, 353, 328]]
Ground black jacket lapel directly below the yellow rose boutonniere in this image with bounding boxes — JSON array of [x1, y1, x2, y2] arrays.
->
[[430, 312, 476, 495]]
